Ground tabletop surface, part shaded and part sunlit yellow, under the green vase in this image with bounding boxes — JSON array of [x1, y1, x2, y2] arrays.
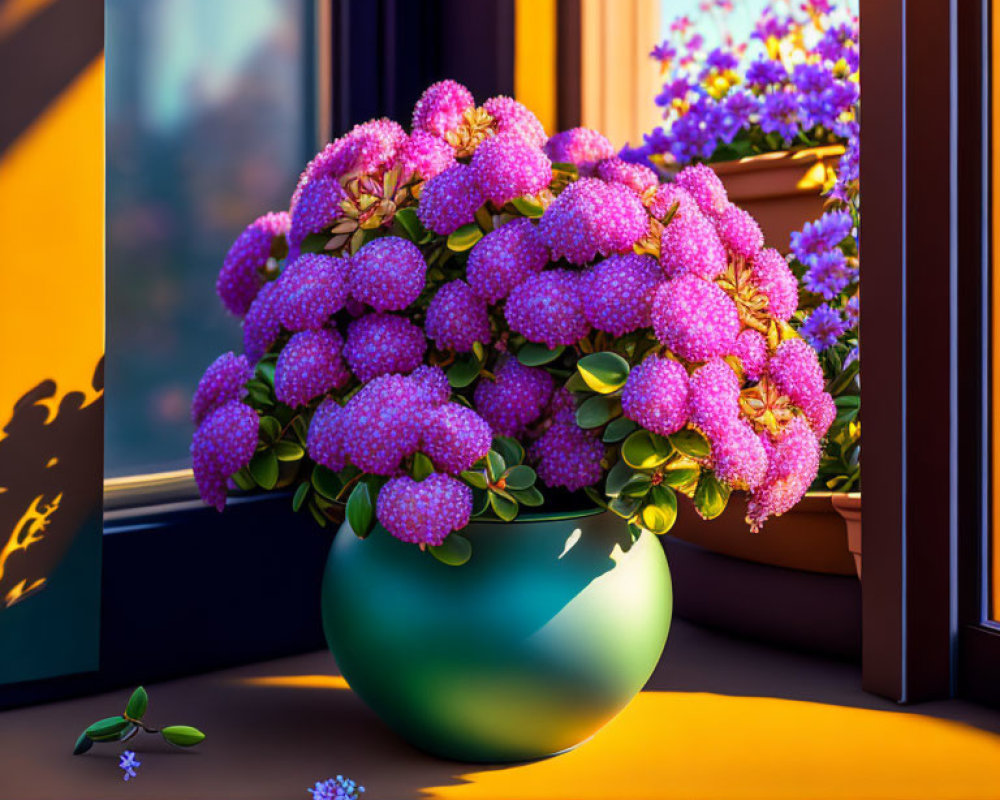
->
[[0, 622, 1000, 800]]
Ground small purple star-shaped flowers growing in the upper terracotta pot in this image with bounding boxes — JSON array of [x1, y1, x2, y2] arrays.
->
[[629, 2, 859, 164]]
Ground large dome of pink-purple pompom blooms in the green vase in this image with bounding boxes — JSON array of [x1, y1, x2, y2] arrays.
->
[[192, 81, 836, 545]]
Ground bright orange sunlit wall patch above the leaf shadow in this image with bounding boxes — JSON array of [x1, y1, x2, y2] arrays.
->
[[0, 57, 104, 424]]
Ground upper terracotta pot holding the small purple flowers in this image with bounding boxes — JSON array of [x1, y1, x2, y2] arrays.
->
[[710, 145, 844, 253]]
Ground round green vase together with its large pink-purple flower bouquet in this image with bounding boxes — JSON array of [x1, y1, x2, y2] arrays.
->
[[191, 81, 836, 761]]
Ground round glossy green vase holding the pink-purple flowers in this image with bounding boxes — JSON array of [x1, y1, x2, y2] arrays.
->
[[322, 511, 673, 762]]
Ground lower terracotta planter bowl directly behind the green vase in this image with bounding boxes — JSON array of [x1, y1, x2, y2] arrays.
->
[[670, 492, 860, 575]]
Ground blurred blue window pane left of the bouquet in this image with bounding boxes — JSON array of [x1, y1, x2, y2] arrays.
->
[[105, 0, 314, 476]]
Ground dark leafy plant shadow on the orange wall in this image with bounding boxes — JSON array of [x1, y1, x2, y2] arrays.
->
[[0, 358, 104, 614]]
